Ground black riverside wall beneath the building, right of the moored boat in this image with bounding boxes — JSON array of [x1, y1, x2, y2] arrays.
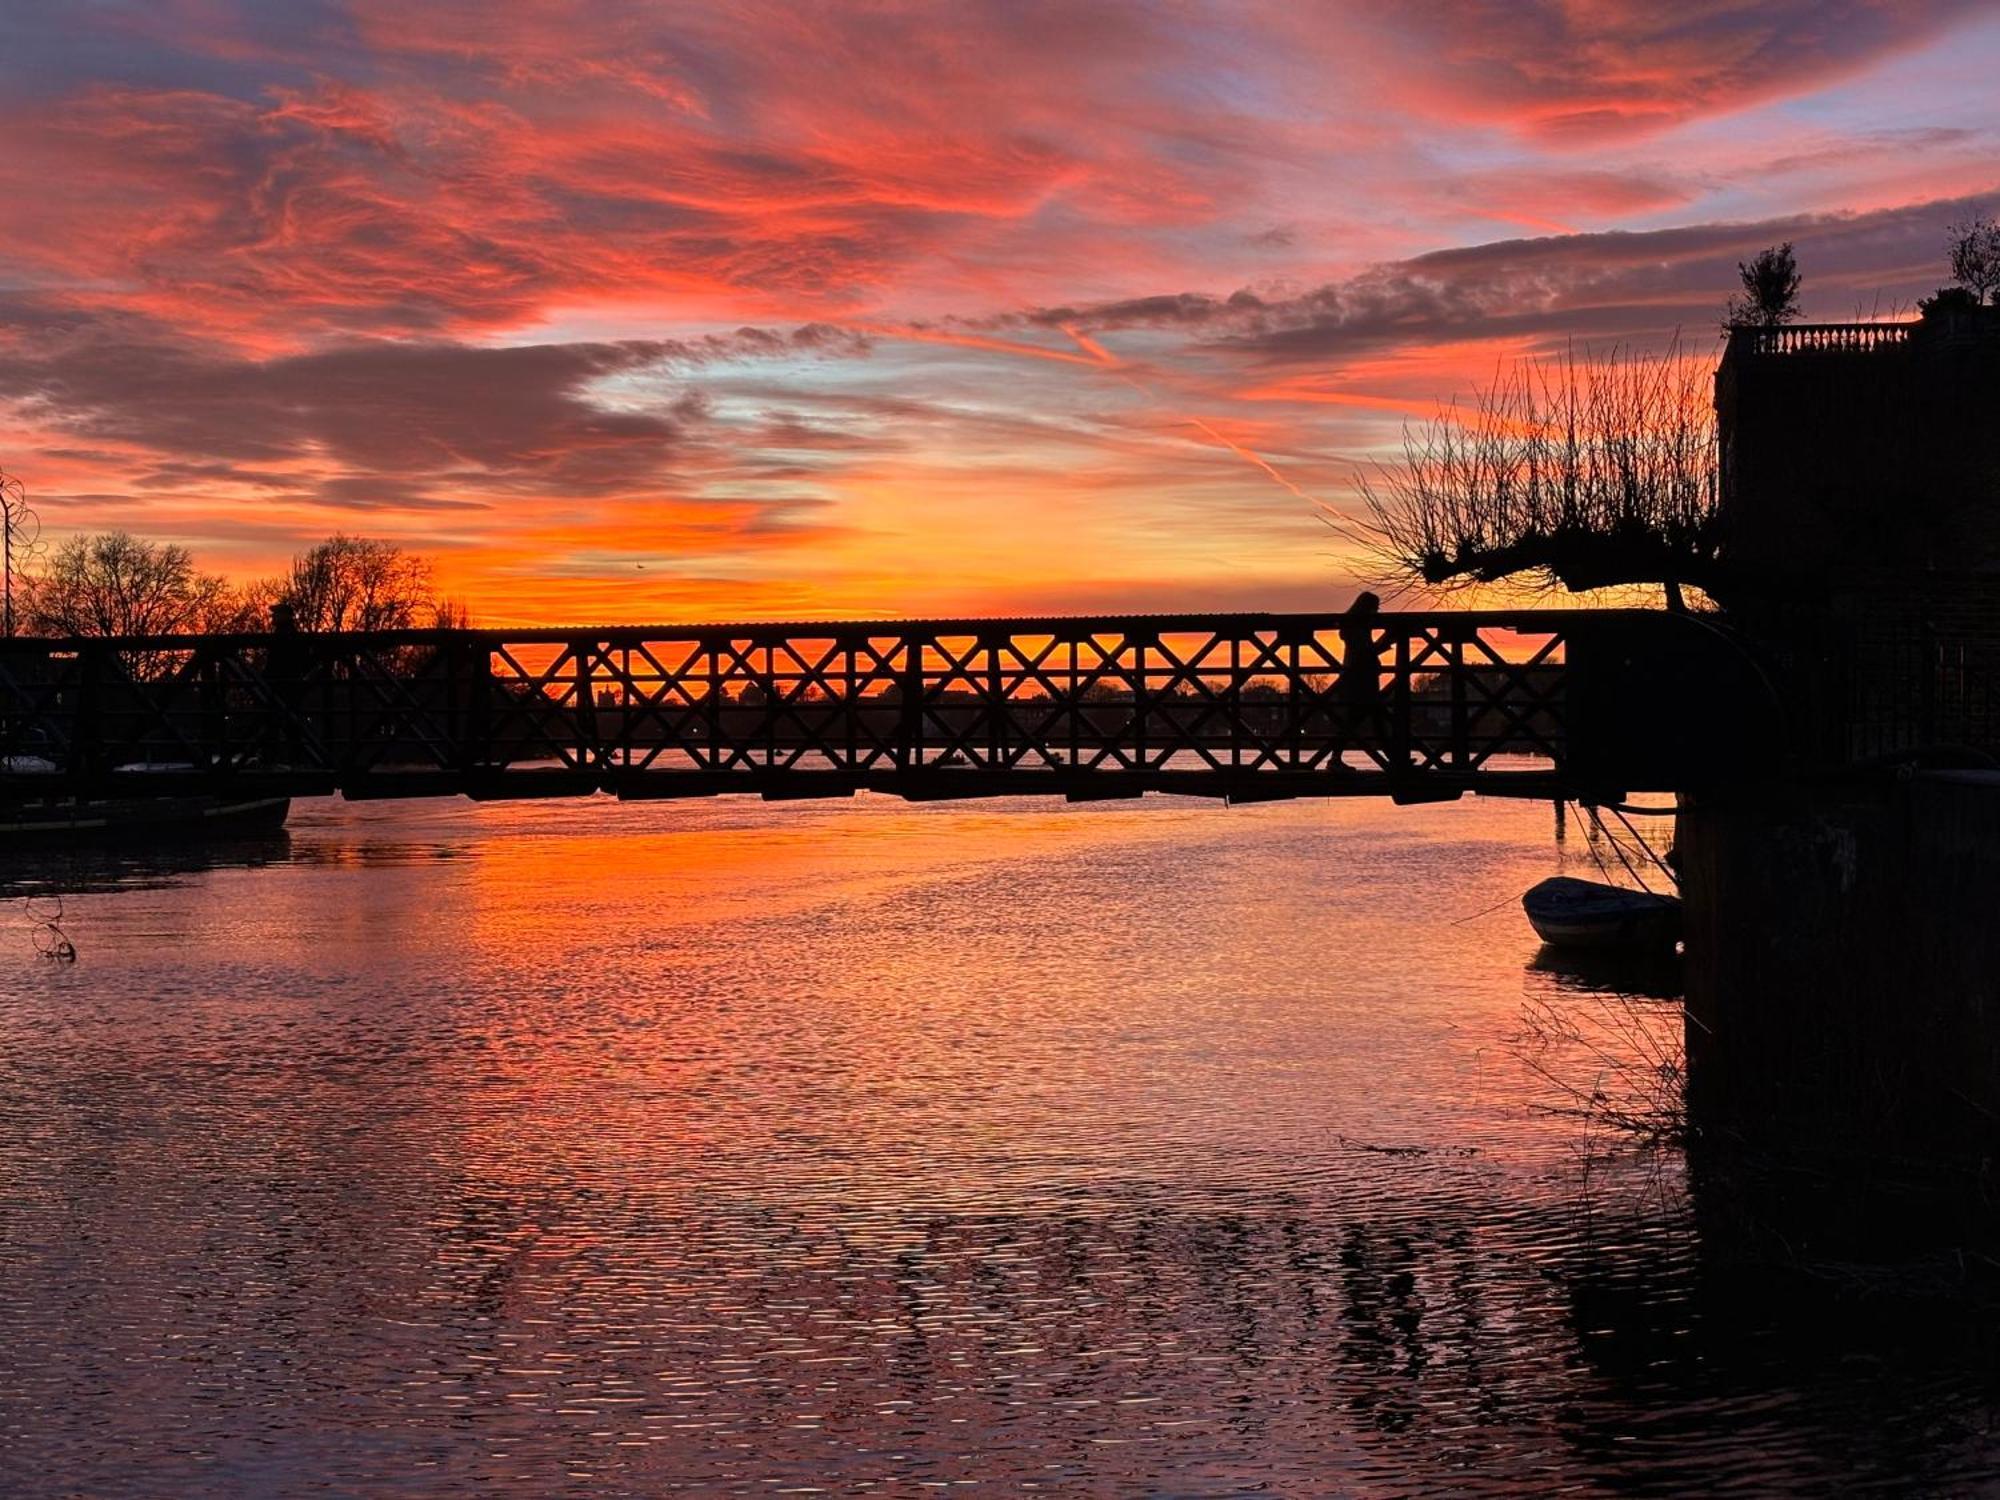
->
[[1678, 772, 2000, 1256]]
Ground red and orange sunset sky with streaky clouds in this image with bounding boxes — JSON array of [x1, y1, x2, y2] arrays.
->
[[0, 0, 2000, 624]]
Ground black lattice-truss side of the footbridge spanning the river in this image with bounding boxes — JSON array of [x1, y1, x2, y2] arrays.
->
[[0, 610, 1608, 796]]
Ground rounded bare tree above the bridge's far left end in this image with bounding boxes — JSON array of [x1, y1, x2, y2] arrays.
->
[[26, 532, 240, 636]]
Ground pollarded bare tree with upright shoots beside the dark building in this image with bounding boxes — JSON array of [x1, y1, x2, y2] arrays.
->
[[1362, 346, 1720, 608]]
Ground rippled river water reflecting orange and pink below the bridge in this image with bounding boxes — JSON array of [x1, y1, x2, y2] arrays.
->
[[0, 800, 2000, 1496]]
